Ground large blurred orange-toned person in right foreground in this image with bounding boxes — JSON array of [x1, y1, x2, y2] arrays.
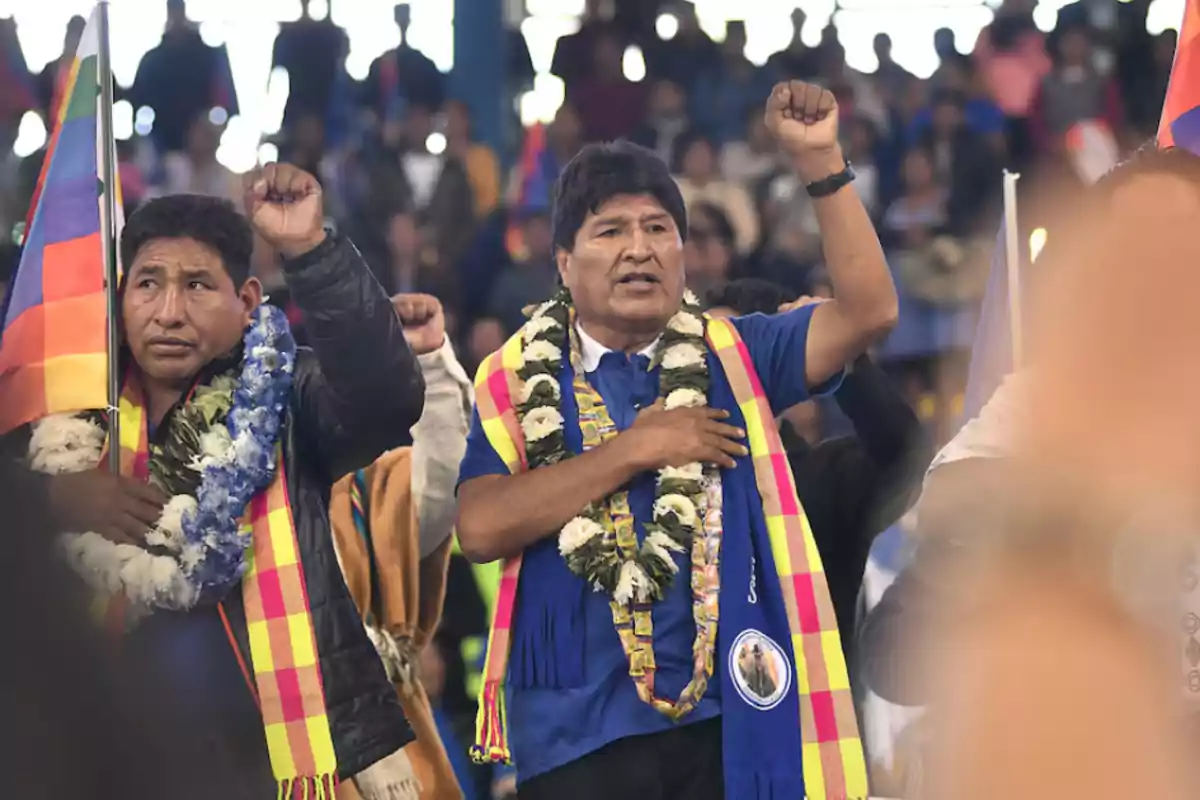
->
[[860, 149, 1200, 800]]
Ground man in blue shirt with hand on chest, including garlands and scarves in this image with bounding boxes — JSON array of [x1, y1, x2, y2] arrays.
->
[[457, 82, 898, 800]]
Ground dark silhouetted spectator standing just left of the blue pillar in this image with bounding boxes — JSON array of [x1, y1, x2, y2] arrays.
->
[[362, 2, 445, 120]]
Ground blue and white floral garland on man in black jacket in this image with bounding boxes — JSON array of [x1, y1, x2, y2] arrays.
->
[[30, 305, 295, 612]]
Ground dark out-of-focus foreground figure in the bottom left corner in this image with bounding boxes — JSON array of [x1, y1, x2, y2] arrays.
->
[[0, 459, 226, 800]]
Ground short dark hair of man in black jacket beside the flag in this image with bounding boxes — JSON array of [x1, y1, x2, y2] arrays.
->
[[121, 194, 254, 288]]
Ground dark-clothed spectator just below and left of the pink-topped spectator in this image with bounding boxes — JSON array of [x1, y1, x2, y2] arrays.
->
[[905, 89, 1001, 235]]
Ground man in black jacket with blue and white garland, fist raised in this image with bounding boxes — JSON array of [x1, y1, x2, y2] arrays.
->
[[16, 164, 427, 800]]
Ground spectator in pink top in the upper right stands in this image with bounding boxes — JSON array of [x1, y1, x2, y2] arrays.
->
[[973, 0, 1051, 168]]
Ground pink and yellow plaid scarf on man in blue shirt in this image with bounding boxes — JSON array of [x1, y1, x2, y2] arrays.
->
[[472, 319, 868, 800]]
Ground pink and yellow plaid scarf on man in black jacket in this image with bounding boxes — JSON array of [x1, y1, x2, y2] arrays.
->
[[108, 375, 337, 800]]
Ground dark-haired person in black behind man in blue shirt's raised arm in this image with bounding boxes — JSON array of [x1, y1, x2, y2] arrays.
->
[[708, 279, 932, 672]]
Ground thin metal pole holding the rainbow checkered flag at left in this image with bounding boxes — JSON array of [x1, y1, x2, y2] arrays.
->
[[96, 0, 121, 475]]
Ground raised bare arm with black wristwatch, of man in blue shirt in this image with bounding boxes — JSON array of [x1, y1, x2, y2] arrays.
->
[[766, 80, 899, 386]]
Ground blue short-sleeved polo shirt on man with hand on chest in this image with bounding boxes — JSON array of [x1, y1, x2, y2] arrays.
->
[[458, 306, 840, 781]]
